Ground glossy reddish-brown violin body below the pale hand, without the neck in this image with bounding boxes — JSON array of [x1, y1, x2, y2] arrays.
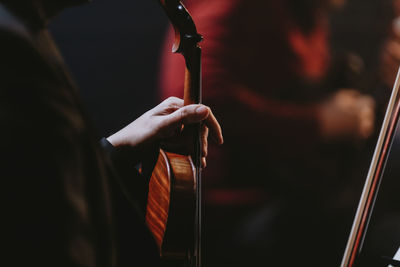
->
[[146, 150, 196, 260]]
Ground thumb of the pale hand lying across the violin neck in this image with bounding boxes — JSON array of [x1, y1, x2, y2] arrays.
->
[[166, 104, 210, 125]]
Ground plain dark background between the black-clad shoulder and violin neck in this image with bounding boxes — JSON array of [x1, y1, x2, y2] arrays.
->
[[50, 0, 172, 136]]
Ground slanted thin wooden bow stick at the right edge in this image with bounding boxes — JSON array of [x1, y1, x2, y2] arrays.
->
[[340, 68, 400, 267]]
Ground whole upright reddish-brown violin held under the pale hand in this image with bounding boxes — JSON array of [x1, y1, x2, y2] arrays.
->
[[145, 0, 202, 267]]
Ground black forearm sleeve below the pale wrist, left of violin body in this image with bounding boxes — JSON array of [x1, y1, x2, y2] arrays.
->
[[100, 138, 160, 266]]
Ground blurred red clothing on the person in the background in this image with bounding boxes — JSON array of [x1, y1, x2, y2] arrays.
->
[[160, 0, 330, 197]]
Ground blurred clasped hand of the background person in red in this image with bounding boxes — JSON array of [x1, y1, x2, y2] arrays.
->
[[319, 89, 375, 140]]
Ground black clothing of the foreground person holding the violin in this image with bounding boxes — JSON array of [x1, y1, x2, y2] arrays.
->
[[0, 0, 158, 267]]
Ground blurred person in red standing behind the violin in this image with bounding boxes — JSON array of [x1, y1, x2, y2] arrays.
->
[[160, 0, 394, 266]]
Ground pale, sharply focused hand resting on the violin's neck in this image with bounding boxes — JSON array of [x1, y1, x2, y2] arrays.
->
[[107, 97, 223, 167]]
